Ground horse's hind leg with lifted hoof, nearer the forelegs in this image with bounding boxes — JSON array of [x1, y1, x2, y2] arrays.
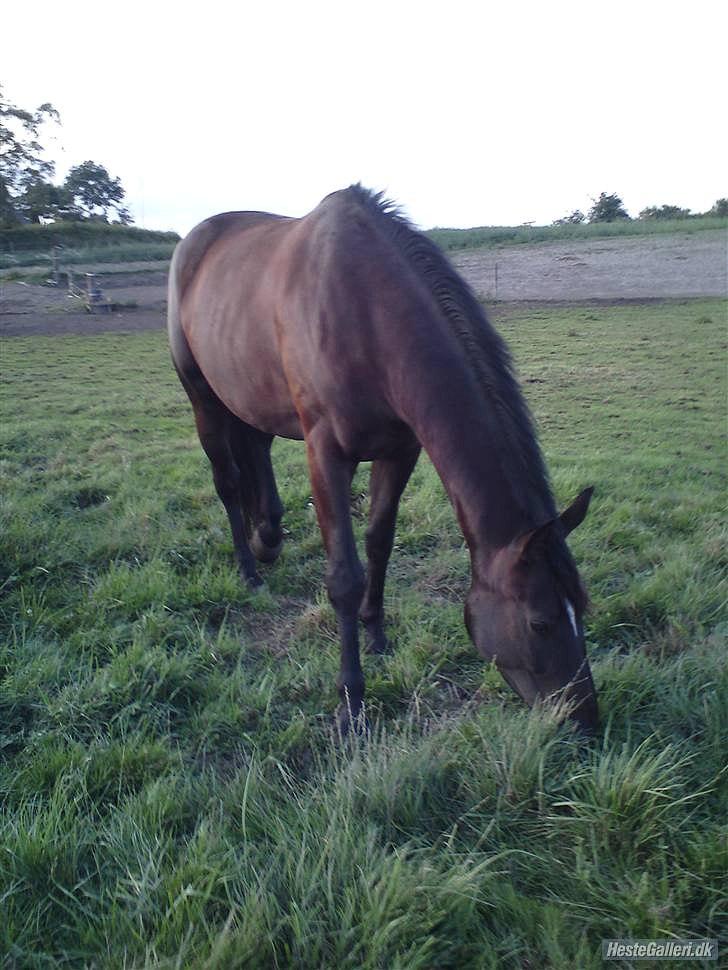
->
[[230, 419, 283, 562]]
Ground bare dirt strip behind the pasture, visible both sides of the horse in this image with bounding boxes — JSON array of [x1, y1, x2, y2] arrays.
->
[[0, 230, 728, 337]]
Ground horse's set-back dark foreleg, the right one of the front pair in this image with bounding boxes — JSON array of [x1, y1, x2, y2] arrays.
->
[[359, 444, 420, 653]]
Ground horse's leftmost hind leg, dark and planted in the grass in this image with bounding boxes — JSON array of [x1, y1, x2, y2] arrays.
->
[[194, 403, 262, 586]]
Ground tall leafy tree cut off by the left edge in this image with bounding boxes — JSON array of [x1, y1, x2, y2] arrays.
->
[[0, 85, 60, 223]]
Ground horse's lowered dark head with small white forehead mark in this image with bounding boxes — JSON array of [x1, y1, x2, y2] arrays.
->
[[465, 488, 598, 731]]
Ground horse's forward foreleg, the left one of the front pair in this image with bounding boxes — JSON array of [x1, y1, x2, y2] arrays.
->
[[306, 429, 364, 733]]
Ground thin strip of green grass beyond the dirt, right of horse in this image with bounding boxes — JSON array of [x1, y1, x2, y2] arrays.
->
[[427, 216, 728, 251]]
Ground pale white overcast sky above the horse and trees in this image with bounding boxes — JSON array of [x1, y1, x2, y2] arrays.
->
[[0, 0, 728, 233]]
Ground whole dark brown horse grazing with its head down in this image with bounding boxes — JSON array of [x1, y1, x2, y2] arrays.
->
[[169, 185, 597, 730]]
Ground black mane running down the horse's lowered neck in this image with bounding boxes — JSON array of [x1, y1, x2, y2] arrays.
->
[[345, 184, 556, 526]]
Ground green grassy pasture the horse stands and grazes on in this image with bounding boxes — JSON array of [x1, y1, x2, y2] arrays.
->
[[0, 300, 728, 970]]
